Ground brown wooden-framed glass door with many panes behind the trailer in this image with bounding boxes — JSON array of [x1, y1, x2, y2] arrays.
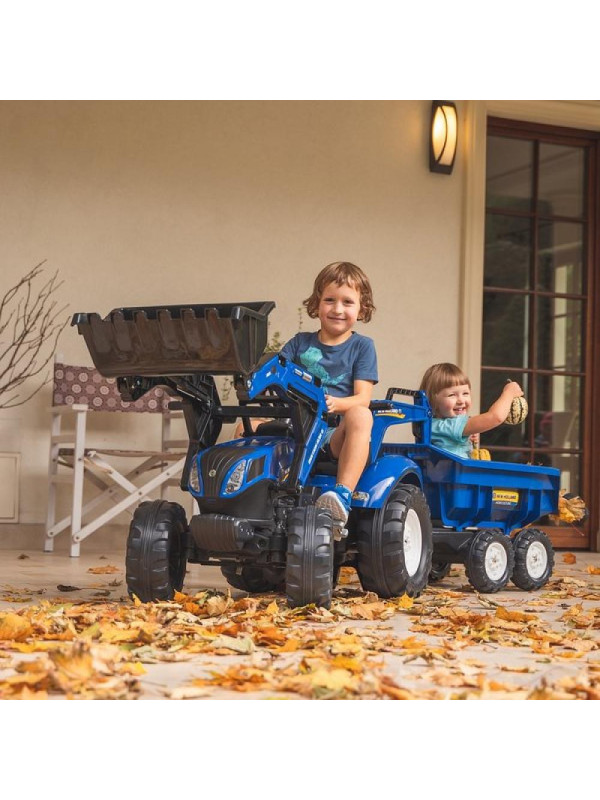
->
[[481, 120, 598, 548]]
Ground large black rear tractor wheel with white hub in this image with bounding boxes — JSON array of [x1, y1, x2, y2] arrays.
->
[[356, 484, 433, 597]]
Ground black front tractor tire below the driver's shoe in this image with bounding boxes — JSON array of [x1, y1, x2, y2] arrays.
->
[[285, 506, 333, 608]]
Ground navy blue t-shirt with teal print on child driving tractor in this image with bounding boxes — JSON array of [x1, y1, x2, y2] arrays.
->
[[281, 332, 378, 397]]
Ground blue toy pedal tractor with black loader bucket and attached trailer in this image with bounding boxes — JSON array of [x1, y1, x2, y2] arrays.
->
[[72, 302, 560, 607]]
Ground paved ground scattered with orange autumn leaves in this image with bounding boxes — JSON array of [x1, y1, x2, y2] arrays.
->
[[0, 554, 600, 700]]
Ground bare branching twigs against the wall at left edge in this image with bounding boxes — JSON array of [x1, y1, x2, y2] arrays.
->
[[0, 261, 68, 408]]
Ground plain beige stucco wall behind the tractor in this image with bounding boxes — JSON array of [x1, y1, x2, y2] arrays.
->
[[0, 101, 465, 524]]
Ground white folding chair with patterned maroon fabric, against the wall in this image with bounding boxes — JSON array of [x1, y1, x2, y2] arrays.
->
[[44, 361, 188, 557]]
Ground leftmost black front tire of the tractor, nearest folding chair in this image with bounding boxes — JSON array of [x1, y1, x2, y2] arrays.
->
[[125, 500, 187, 603]]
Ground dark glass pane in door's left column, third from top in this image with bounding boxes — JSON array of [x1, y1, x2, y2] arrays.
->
[[482, 291, 529, 370]]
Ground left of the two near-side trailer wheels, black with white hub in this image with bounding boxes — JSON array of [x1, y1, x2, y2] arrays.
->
[[465, 529, 515, 594]]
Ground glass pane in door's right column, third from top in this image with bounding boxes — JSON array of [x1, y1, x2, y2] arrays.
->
[[535, 297, 583, 372]]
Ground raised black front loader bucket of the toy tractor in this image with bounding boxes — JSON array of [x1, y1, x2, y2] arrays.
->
[[71, 301, 275, 378]]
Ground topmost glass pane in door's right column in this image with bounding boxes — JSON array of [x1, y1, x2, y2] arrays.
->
[[538, 144, 584, 217]]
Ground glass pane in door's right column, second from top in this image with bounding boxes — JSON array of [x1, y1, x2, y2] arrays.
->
[[538, 222, 583, 294]]
